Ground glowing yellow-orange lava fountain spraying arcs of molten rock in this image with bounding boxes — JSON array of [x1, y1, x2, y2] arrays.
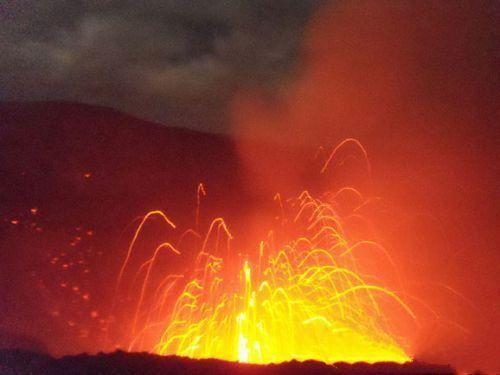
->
[[111, 140, 415, 363]]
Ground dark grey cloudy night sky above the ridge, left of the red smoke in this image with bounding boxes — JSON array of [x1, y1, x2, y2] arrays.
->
[[0, 0, 321, 130]]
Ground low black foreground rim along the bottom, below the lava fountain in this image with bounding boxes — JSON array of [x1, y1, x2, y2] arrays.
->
[[0, 350, 456, 375]]
